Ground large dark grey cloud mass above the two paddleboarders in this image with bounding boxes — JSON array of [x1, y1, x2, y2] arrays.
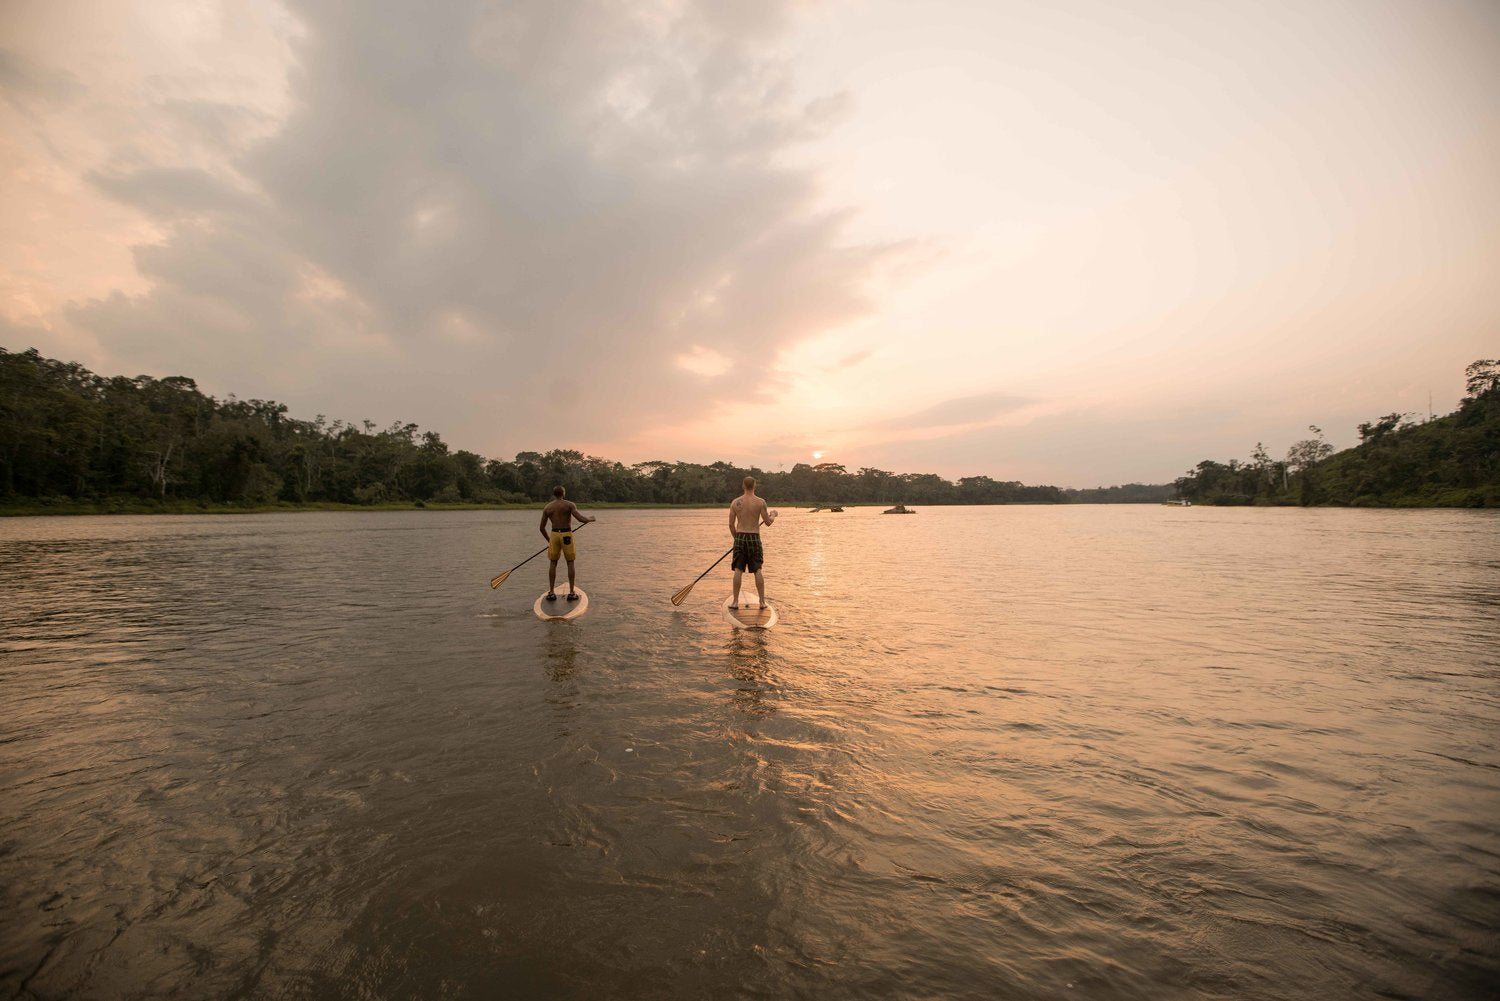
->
[[72, 0, 893, 453]]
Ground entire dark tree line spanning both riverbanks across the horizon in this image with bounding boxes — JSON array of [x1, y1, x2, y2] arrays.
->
[[0, 348, 1500, 516]]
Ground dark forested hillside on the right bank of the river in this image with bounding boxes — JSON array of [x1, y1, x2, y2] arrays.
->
[[1176, 359, 1500, 507]]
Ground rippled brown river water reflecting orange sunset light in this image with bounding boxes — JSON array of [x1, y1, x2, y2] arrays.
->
[[0, 506, 1500, 1001]]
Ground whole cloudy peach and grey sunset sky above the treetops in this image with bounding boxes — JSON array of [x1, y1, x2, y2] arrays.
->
[[0, 0, 1500, 486]]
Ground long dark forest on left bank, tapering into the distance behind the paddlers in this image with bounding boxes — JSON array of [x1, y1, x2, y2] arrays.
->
[[0, 348, 1146, 510]]
